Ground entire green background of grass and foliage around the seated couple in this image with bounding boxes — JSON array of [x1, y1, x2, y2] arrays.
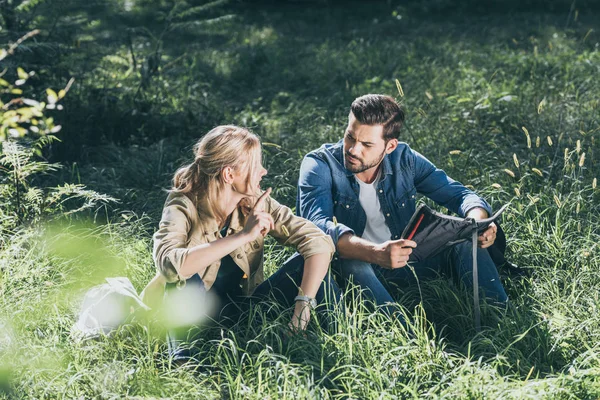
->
[[0, 0, 600, 399]]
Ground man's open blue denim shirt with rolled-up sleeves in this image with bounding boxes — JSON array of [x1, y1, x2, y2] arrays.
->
[[296, 140, 492, 253]]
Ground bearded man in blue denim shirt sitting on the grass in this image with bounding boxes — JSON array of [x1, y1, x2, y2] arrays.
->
[[296, 94, 508, 313]]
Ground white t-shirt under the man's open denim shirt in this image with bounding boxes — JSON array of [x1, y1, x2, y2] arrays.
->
[[354, 171, 392, 244]]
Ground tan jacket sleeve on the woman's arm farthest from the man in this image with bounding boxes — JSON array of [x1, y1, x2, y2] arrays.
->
[[152, 195, 191, 282]]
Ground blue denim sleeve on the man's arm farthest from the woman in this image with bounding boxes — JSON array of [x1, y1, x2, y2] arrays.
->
[[411, 149, 492, 217]]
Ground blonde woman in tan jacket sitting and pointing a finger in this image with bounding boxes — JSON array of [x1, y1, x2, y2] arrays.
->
[[142, 125, 338, 355]]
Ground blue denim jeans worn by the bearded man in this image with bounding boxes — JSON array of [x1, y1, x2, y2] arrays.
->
[[332, 242, 508, 315]]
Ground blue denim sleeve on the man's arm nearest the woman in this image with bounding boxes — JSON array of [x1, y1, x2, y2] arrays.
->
[[296, 154, 354, 248]]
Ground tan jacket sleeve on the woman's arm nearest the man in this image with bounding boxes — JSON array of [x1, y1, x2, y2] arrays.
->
[[266, 197, 335, 260]]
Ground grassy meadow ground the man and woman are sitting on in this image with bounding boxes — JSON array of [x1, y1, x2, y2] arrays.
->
[[0, 3, 600, 399]]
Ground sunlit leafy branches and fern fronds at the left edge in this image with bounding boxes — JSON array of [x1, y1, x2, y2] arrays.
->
[[0, 36, 115, 247]]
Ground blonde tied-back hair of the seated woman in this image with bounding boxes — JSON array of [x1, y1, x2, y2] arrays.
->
[[172, 125, 261, 217]]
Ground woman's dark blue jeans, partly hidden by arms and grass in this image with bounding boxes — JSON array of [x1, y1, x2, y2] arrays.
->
[[165, 253, 343, 361]]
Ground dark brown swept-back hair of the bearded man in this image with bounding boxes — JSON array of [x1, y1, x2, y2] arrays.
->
[[350, 94, 404, 141]]
